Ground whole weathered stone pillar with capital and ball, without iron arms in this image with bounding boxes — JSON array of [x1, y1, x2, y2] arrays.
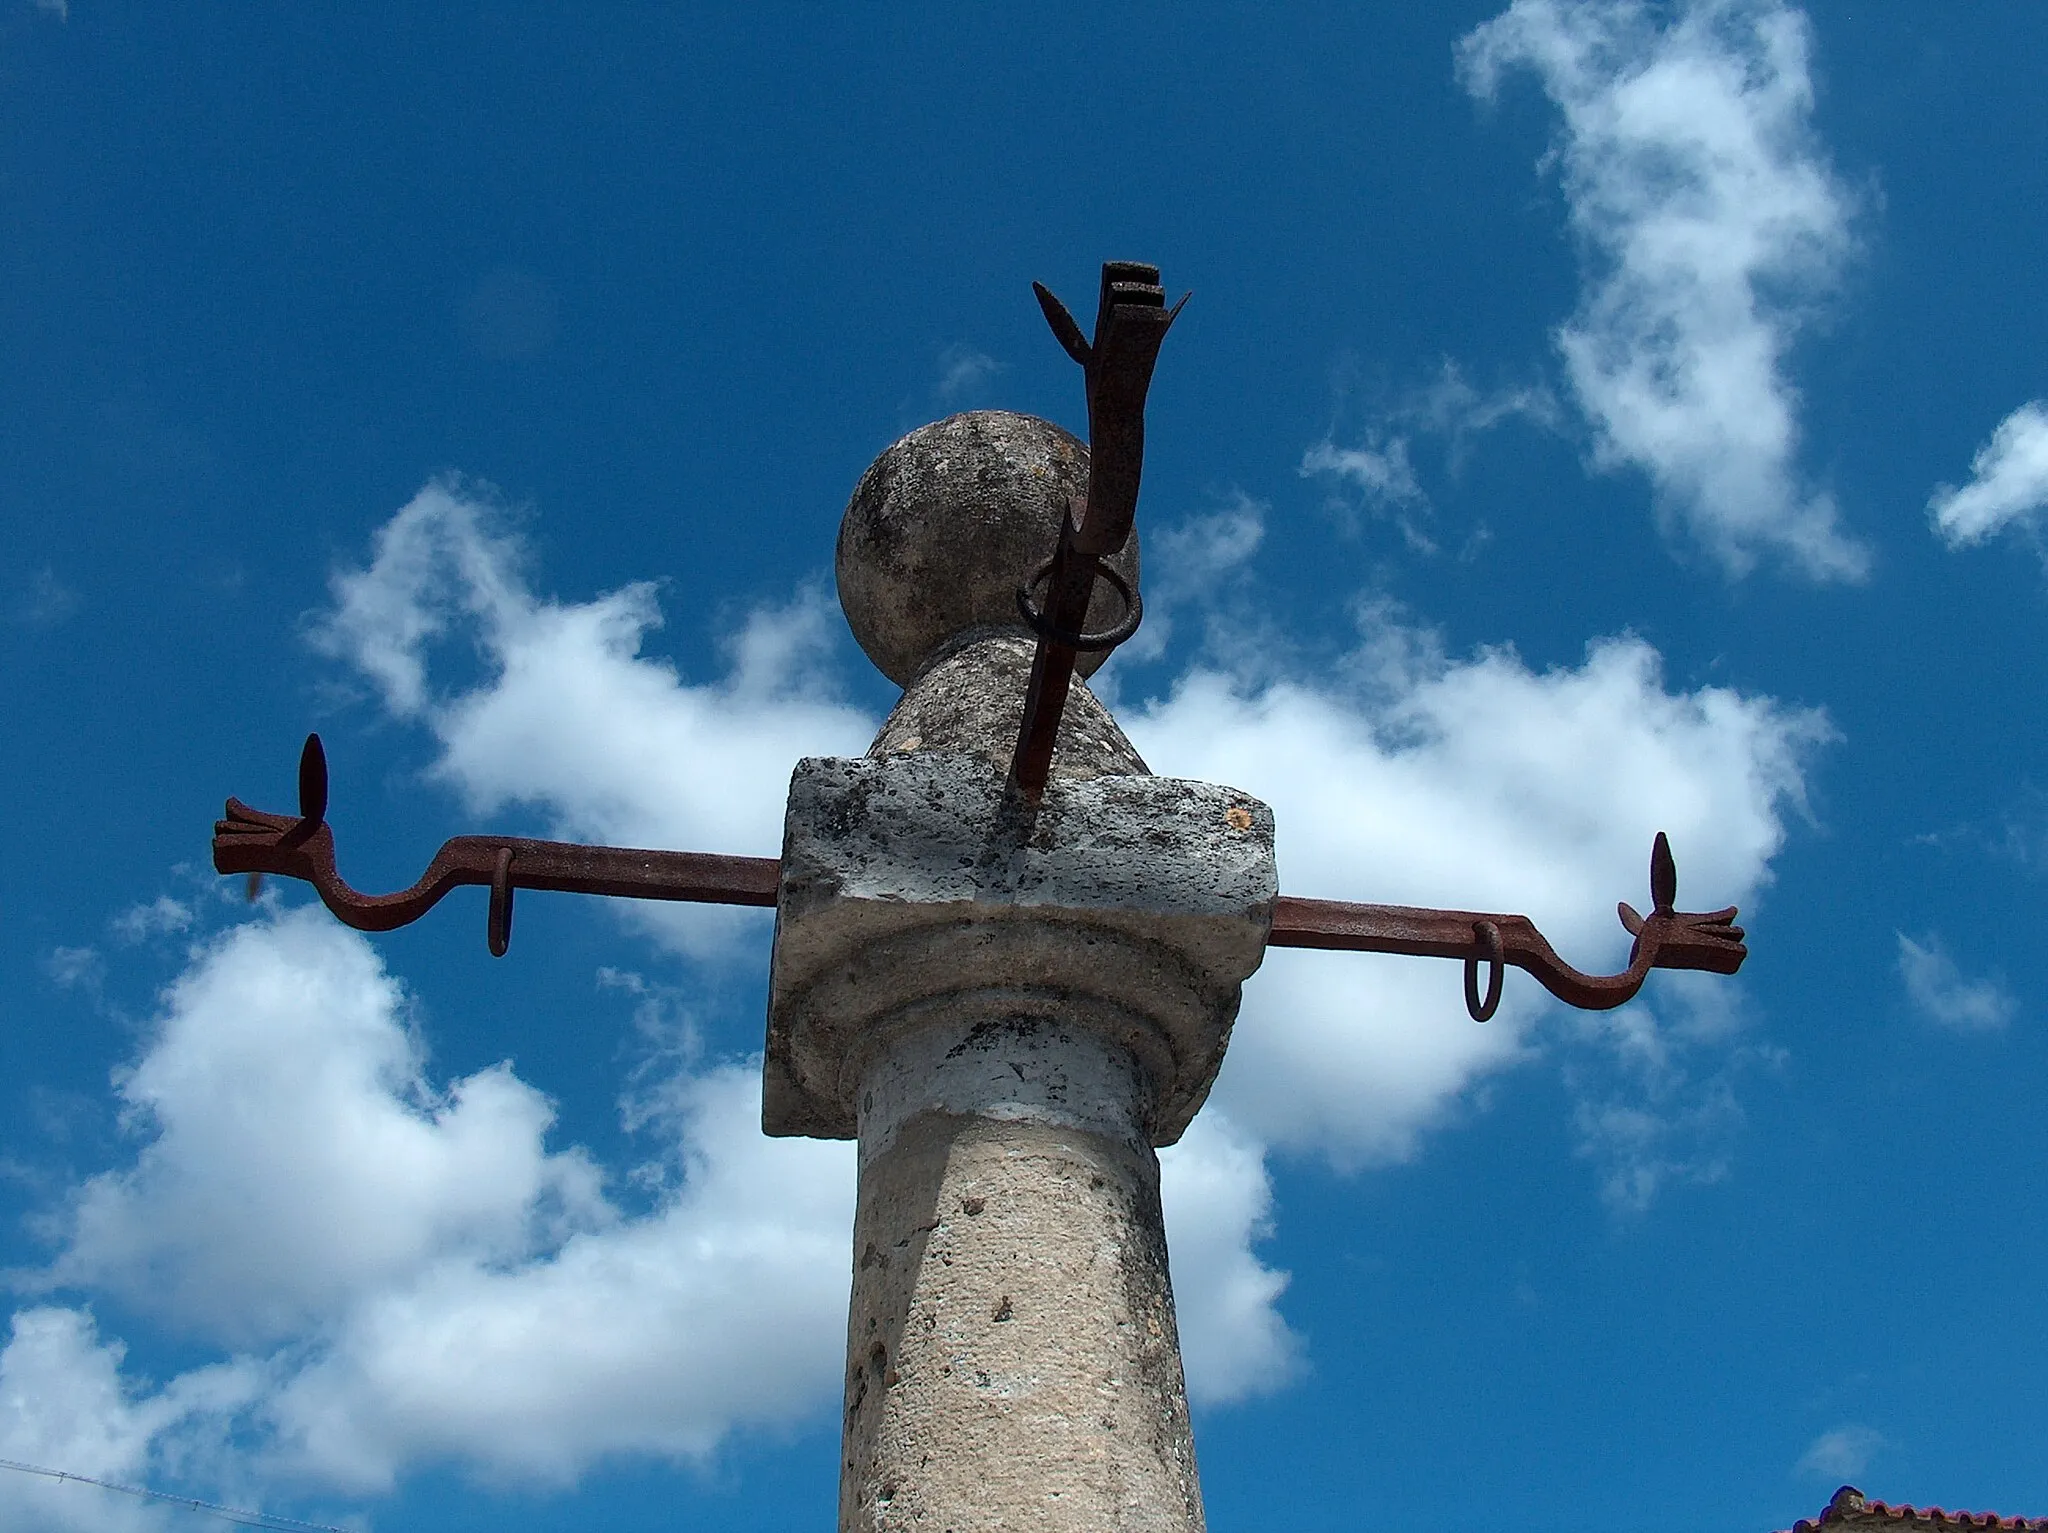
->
[[764, 415, 1276, 1533]]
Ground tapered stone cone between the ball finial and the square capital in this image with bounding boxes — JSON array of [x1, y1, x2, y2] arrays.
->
[[868, 628, 1147, 778]]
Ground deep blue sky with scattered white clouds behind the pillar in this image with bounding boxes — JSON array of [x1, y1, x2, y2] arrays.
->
[[0, 0, 2048, 1533]]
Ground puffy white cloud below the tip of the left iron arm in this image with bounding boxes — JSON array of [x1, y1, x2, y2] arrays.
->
[[53, 907, 608, 1345]]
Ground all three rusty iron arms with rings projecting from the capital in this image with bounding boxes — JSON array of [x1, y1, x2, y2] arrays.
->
[[213, 262, 1749, 1021]]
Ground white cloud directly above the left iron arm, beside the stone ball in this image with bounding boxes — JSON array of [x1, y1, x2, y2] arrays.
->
[[313, 481, 874, 956]]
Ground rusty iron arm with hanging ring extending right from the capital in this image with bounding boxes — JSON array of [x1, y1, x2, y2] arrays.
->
[[1266, 831, 1749, 1021]]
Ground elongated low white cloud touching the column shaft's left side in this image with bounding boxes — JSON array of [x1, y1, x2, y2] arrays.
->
[[272, 1064, 854, 1490]]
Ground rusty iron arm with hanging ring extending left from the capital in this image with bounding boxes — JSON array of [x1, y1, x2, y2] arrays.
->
[[213, 735, 782, 958]]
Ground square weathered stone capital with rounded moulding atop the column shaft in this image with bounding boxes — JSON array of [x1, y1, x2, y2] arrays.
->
[[762, 751, 1278, 1144]]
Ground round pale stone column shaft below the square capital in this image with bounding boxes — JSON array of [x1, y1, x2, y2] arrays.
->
[[840, 1021, 1202, 1533]]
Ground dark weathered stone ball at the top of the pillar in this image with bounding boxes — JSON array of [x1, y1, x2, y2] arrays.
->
[[838, 409, 1139, 686]]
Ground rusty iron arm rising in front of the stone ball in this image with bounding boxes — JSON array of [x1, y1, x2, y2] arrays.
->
[[1010, 260, 1188, 802]]
